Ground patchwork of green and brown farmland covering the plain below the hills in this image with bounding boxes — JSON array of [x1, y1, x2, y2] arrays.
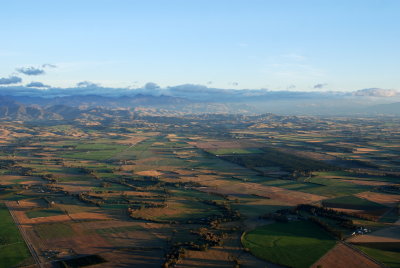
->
[[0, 115, 400, 267]]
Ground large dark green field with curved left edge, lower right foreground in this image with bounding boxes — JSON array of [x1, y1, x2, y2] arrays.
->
[[242, 221, 336, 268]]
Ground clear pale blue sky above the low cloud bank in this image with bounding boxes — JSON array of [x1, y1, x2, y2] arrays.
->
[[0, 0, 400, 91]]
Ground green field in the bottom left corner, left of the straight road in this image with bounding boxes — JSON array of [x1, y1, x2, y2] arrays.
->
[[0, 203, 31, 268]]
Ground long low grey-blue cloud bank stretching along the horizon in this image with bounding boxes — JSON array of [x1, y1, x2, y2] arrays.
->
[[0, 80, 400, 105]]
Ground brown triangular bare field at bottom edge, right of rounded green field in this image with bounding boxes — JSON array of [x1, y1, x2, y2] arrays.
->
[[311, 243, 381, 268]]
